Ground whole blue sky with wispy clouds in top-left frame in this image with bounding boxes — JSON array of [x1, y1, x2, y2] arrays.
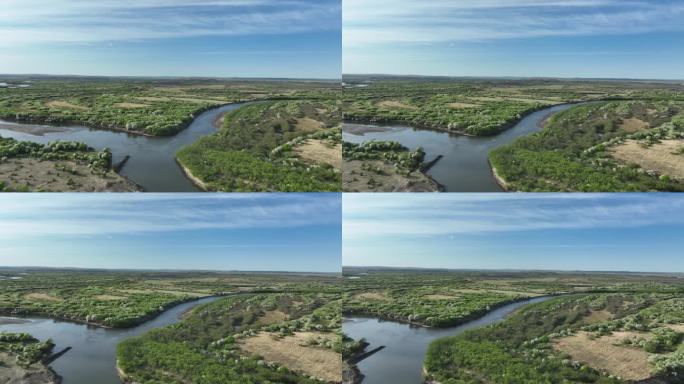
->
[[0, 0, 342, 79]]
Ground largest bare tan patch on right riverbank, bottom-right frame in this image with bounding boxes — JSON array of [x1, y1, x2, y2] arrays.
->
[[553, 332, 651, 381]]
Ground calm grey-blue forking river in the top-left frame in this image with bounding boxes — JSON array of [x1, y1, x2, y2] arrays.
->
[[0, 104, 243, 192]]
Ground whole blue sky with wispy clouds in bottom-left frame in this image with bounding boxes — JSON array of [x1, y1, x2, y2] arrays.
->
[[0, 193, 341, 272]]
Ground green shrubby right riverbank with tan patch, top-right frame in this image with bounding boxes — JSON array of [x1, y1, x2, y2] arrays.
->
[[490, 100, 684, 192]]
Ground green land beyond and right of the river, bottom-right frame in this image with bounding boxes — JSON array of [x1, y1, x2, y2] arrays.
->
[[343, 268, 684, 384]]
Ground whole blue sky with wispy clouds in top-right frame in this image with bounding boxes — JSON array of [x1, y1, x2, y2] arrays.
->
[[343, 0, 684, 79]]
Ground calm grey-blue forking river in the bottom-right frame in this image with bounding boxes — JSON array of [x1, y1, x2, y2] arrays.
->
[[342, 297, 550, 384]]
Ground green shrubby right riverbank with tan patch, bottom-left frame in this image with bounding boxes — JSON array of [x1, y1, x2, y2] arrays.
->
[[117, 290, 342, 384]]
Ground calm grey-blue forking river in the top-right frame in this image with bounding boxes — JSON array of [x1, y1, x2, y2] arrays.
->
[[342, 104, 572, 192]]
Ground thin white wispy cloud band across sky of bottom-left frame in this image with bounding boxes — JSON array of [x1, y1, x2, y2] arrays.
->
[[0, 194, 341, 239]]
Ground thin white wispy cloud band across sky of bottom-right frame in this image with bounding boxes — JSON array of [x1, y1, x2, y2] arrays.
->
[[343, 194, 684, 241]]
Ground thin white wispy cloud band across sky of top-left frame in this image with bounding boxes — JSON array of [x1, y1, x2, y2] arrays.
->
[[0, 0, 340, 47]]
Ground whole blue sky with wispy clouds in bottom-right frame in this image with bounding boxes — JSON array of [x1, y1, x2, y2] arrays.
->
[[342, 193, 684, 272]]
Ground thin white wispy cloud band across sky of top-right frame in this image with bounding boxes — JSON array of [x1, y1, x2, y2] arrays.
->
[[343, 0, 684, 48]]
